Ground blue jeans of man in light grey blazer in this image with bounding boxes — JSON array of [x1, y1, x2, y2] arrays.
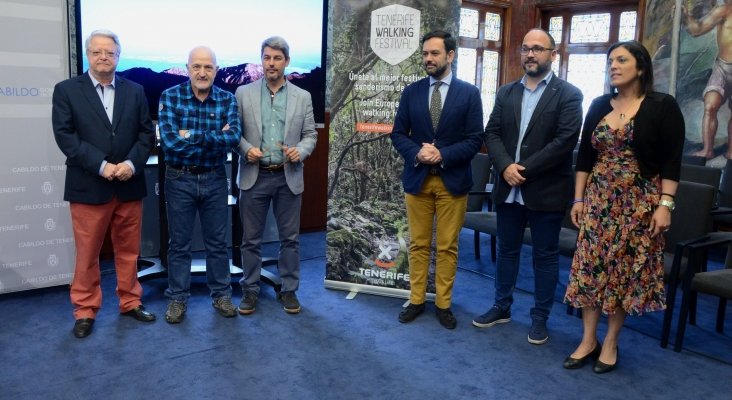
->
[[239, 170, 302, 293]]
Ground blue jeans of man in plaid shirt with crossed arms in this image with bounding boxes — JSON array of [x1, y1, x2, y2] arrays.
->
[[165, 165, 231, 301]]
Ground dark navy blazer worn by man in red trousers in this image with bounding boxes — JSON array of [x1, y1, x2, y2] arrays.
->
[[51, 73, 155, 204]]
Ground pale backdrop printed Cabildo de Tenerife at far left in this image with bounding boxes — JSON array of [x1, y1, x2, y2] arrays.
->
[[0, 0, 74, 293]]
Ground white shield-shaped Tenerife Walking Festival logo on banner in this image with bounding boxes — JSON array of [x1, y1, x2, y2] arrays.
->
[[371, 4, 421, 65]]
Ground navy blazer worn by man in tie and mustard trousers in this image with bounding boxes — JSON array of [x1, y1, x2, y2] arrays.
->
[[391, 75, 483, 195]]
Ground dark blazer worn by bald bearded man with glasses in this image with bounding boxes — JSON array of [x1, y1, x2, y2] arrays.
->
[[485, 76, 582, 211]]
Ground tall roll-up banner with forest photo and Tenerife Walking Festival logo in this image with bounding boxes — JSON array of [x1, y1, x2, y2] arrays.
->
[[325, 0, 460, 297]]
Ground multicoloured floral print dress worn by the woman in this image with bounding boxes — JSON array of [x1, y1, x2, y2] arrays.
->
[[564, 119, 666, 315]]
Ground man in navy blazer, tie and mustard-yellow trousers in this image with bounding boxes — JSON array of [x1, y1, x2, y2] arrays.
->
[[391, 31, 483, 329]]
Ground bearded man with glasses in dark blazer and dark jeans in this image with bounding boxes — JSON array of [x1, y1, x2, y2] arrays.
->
[[473, 29, 582, 344]]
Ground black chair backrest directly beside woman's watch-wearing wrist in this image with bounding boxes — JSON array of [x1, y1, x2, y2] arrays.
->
[[665, 180, 717, 253]]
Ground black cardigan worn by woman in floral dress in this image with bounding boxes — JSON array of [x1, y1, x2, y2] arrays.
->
[[576, 92, 686, 181]]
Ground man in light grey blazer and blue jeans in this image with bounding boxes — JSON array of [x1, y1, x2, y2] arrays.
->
[[236, 36, 317, 315]]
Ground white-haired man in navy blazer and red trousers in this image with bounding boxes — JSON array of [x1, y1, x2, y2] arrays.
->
[[52, 30, 155, 338]]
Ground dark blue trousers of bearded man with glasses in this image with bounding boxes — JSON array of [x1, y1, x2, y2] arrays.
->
[[495, 203, 564, 321]]
